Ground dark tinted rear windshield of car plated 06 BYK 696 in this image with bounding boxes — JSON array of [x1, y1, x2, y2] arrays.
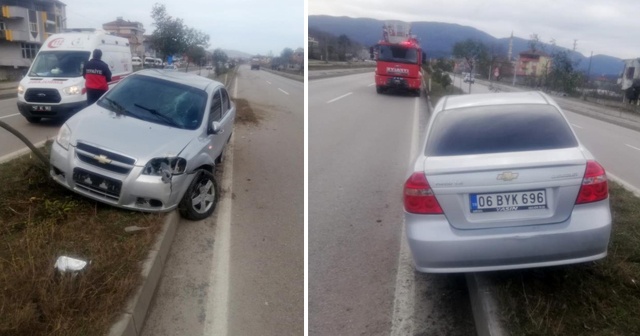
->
[[425, 105, 578, 156]]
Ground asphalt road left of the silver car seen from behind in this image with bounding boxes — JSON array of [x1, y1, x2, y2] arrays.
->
[[308, 73, 474, 335]]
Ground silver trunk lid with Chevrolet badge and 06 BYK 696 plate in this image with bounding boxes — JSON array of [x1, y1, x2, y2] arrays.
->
[[424, 148, 586, 229]]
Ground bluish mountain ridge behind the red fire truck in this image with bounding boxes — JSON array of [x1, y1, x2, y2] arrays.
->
[[309, 15, 623, 76]]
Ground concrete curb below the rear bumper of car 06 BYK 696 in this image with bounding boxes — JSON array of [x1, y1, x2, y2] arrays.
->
[[466, 273, 508, 336]]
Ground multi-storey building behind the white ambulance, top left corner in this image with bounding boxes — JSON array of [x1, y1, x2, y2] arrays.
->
[[0, 0, 67, 80]]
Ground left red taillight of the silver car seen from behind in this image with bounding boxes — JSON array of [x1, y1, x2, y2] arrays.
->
[[404, 172, 443, 214]]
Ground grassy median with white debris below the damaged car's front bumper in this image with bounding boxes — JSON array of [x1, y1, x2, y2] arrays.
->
[[0, 144, 164, 336]]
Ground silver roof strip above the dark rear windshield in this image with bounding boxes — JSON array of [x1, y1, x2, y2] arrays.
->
[[438, 91, 557, 110]]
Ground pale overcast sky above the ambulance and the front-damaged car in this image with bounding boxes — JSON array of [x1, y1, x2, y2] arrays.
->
[[61, 0, 306, 55]]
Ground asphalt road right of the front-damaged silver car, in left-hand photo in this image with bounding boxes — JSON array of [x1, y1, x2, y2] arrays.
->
[[142, 66, 304, 336]]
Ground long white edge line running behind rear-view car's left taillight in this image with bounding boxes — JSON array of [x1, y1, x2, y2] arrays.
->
[[391, 99, 420, 336]]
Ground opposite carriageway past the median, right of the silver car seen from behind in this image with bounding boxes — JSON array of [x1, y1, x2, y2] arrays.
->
[[453, 76, 640, 189]]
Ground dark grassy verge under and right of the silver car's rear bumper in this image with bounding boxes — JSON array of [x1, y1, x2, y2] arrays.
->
[[491, 182, 640, 336]]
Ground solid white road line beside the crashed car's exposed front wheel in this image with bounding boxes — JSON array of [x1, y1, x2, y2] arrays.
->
[[203, 134, 235, 336]]
